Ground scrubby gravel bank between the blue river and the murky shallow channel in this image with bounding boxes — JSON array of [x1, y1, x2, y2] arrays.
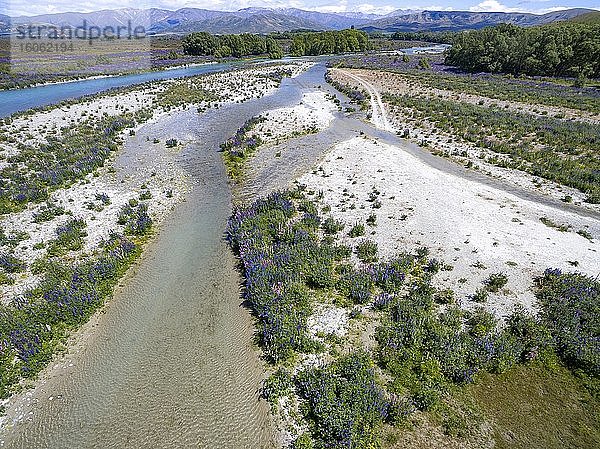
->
[[0, 63, 309, 410]]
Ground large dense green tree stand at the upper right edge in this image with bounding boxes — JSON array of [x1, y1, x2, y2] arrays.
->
[[445, 23, 600, 78]]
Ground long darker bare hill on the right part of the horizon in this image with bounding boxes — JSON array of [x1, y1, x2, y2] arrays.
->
[[362, 8, 591, 32]]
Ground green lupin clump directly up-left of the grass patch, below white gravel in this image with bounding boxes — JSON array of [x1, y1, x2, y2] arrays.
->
[[377, 281, 524, 410]]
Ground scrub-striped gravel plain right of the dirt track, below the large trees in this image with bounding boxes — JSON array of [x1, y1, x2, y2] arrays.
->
[[328, 56, 600, 204]]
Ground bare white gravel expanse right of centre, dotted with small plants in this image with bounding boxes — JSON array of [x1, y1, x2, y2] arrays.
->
[[299, 137, 600, 319]]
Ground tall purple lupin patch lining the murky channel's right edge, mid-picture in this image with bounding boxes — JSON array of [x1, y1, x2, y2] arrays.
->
[[226, 192, 316, 362]]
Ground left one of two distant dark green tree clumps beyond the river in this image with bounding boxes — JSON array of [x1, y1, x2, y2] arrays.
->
[[182, 31, 283, 59]]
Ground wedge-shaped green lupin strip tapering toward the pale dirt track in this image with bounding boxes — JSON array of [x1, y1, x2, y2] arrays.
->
[[384, 94, 600, 203]]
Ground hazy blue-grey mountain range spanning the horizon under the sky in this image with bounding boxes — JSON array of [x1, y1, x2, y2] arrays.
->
[[7, 8, 592, 34]]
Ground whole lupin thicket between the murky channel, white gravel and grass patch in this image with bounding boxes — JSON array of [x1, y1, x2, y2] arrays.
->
[[226, 188, 600, 448]]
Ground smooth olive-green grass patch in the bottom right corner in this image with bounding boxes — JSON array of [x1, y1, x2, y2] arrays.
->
[[469, 363, 600, 449]]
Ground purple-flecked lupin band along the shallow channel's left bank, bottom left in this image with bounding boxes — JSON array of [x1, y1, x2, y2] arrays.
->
[[0, 235, 139, 398]]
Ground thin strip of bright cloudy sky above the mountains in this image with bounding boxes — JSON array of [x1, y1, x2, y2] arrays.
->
[[0, 0, 600, 16]]
